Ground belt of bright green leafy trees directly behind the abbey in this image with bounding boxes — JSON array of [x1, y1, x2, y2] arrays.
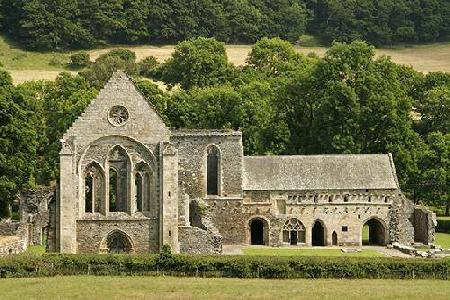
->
[[0, 37, 450, 215]]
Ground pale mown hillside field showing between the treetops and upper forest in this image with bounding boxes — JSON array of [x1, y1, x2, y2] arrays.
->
[[0, 37, 450, 83]]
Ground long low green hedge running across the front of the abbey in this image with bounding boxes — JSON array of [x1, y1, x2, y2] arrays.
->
[[0, 251, 450, 279]]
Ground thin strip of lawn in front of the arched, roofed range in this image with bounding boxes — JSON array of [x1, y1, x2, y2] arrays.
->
[[242, 247, 384, 257]]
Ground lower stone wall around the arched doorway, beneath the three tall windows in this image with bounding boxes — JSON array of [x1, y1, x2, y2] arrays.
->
[[76, 219, 159, 253]]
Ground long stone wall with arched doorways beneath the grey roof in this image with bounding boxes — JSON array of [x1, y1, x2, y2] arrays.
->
[[207, 190, 413, 246]]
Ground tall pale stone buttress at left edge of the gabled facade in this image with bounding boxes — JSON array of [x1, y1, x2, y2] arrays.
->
[[56, 140, 78, 253]]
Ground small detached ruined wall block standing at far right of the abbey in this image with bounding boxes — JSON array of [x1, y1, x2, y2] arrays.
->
[[414, 207, 436, 245]]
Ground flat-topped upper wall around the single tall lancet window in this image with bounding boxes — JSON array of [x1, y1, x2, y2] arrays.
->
[[171, 130, 243, 199]]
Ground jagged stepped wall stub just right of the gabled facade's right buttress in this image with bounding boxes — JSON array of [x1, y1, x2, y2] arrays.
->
[[178, 200, 223, 254]]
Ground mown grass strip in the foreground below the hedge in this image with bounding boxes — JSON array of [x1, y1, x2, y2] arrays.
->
[[0, 276, 450, 300]]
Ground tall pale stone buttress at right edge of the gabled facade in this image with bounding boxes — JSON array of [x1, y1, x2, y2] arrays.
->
[[160, 143, 180, 253]]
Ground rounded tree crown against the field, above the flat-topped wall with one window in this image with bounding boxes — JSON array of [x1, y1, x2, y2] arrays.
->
[[161, 37, 234, 90]]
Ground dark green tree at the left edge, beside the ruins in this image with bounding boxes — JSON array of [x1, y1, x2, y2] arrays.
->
[[0, 71, 37, 217]]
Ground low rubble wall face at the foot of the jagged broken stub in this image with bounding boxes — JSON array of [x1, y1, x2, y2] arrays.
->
[[178, 226, 222, 254]]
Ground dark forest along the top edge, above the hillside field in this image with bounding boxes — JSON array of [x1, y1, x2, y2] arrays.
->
[[0, 0, 450, 50]]
